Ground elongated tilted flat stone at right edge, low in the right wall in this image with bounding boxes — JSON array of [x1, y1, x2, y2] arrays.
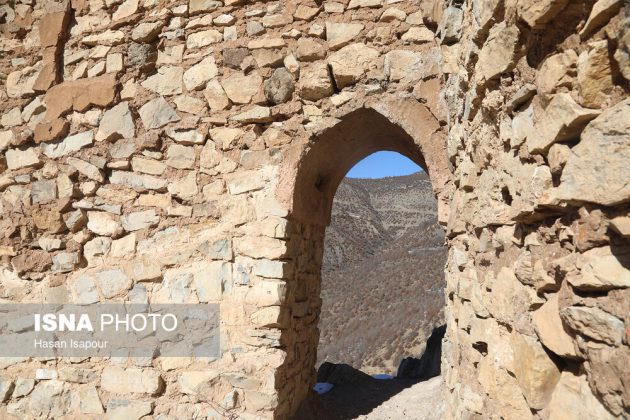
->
[[560, 306, 624, 346]]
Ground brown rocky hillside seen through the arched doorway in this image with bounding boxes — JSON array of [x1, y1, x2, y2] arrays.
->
[[318, 173, 446, 374]]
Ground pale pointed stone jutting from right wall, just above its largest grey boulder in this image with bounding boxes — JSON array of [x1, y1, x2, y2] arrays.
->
[[527, 93, 599, 153]]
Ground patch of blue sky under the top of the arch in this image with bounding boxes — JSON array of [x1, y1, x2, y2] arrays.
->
[[346, 152, 422, 178]]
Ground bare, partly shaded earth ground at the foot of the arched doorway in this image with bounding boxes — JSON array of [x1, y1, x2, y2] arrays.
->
[[294, 376, 445, 420]]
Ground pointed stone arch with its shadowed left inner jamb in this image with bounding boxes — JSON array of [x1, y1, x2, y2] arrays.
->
[[276, 97, 450, 418]]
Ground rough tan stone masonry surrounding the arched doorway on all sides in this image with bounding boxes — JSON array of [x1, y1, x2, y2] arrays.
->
[[0, 0, 630, 420]]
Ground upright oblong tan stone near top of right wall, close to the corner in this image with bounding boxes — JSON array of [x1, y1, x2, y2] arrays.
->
[[477, 23, 520, 80]]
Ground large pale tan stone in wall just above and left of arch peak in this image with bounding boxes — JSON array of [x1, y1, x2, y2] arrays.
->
[[328, 44, 379, 89]]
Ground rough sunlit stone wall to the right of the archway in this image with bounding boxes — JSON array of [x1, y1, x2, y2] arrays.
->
[[443, 0, 630, 418]]
